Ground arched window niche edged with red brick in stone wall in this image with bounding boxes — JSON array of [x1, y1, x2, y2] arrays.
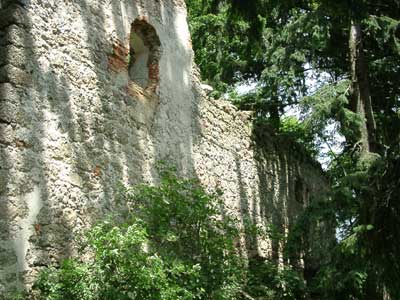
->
[[128, 18, 161, 91]]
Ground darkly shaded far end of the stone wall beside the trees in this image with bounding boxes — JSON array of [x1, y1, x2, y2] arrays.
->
[[255, 132, 335, 280]]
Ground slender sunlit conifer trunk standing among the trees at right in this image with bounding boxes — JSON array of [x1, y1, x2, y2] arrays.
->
[[349, 19, 376, 153]]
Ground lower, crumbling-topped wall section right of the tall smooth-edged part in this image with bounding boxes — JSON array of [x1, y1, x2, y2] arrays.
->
[[193, 92, 331, 267]]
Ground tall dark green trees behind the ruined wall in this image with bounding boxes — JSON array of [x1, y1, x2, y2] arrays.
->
[[186, 0, 400, 299]]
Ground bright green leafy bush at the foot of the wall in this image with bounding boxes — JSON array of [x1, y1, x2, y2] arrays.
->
[[28, 165, 306, 300]]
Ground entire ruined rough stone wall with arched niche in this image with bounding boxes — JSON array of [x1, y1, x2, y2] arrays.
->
[[0, 0, 324, 298]]
